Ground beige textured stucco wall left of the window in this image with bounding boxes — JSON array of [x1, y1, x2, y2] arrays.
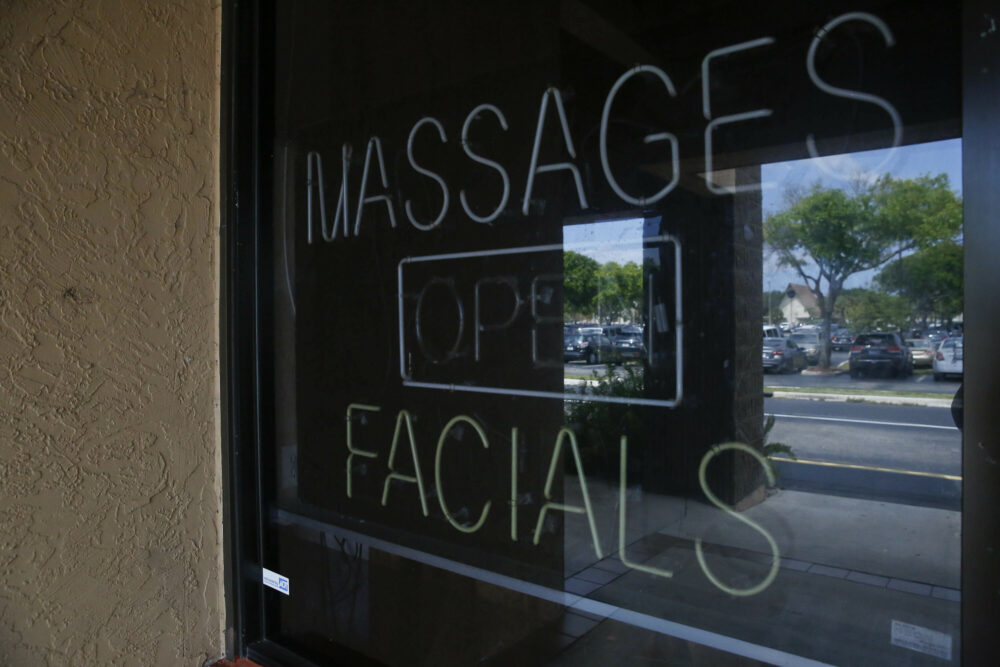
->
[[0, 0, 223, 665]]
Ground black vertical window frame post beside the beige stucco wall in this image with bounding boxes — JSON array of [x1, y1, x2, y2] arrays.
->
[[219, 0, 263, 656]]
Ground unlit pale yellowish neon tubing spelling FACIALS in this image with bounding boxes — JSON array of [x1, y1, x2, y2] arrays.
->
[[345, 403, 780, 596]]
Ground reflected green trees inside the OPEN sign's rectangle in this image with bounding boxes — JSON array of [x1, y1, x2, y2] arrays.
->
[[563, 251, 642, 323]]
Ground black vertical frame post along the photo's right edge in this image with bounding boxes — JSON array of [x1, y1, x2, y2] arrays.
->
[[962, 0, 1000, 665]]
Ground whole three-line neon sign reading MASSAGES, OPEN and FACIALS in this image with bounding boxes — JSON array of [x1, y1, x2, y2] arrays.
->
[[305, 12, 902, 596]]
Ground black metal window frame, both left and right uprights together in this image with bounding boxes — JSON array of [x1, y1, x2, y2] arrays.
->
[[219, 0, 1000, 665]]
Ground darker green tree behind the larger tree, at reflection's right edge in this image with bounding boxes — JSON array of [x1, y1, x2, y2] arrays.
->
[[875, 241, 964, 327]]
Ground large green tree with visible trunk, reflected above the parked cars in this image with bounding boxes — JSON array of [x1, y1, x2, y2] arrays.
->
[[764, 174, 962, 368]]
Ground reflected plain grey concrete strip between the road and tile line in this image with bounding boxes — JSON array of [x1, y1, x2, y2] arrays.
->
[[566, 476, 961, 597]]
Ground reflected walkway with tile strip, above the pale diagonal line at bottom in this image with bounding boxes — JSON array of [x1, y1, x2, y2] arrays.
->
[[565, 477, 961, 664]]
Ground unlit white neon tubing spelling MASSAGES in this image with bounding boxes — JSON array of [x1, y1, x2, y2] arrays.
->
[[306, 12, 903, 244]]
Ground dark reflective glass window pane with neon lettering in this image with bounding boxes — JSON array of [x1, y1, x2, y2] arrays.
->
[[229, 0, 992, 665]]
